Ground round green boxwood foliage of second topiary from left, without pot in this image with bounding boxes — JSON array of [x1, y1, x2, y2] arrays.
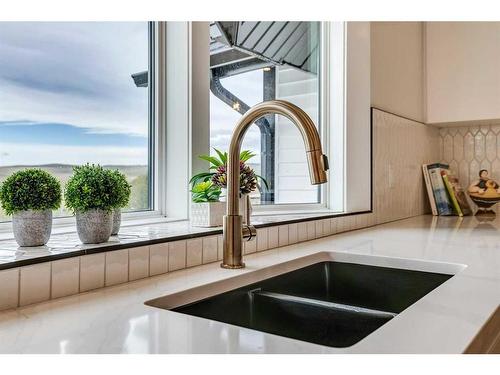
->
[[64, 164, 124, 212]]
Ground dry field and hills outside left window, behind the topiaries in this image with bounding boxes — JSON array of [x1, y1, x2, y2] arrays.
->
[[0, 164, 148, 221]]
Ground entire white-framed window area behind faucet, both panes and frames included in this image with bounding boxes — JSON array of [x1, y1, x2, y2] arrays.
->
[[0, 22, 371, 226]]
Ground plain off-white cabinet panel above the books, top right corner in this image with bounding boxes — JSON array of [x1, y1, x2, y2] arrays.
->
[[426, 22, 500, 123]]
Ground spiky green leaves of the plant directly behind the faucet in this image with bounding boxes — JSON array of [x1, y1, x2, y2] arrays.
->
[[189, 148, 269, 194]]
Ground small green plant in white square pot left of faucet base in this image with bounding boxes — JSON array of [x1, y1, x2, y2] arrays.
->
[[191, 181, 226, 227]]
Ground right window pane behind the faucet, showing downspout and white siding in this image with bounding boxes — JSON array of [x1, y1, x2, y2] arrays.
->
[[210, 21, 321, 205]]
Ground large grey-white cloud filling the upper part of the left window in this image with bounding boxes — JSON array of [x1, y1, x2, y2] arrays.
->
[[0, 22, 148, 135]]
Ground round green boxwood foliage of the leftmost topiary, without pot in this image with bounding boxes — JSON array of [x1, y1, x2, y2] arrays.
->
[[0, 168, 61, 215]]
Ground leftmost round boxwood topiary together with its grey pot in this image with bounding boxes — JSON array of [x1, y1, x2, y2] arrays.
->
[[0, 168, 61, 246]]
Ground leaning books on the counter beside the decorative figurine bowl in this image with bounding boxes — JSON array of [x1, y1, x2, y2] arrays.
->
[[422, 163, 472, 216]]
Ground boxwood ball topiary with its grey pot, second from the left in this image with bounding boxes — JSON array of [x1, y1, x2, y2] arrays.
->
[[64, 164, 119, 244]]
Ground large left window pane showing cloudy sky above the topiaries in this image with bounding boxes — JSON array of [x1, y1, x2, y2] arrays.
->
[[0, 22, 153, 221]]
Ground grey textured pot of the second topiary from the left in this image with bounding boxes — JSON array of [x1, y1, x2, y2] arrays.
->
[[76, 210, 113, 243]]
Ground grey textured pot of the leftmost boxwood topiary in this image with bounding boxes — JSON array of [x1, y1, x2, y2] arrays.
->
[[12, 210, 52, 246]]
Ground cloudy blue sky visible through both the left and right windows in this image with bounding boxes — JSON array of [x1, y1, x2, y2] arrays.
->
[[0, 22, 270, 165]]
